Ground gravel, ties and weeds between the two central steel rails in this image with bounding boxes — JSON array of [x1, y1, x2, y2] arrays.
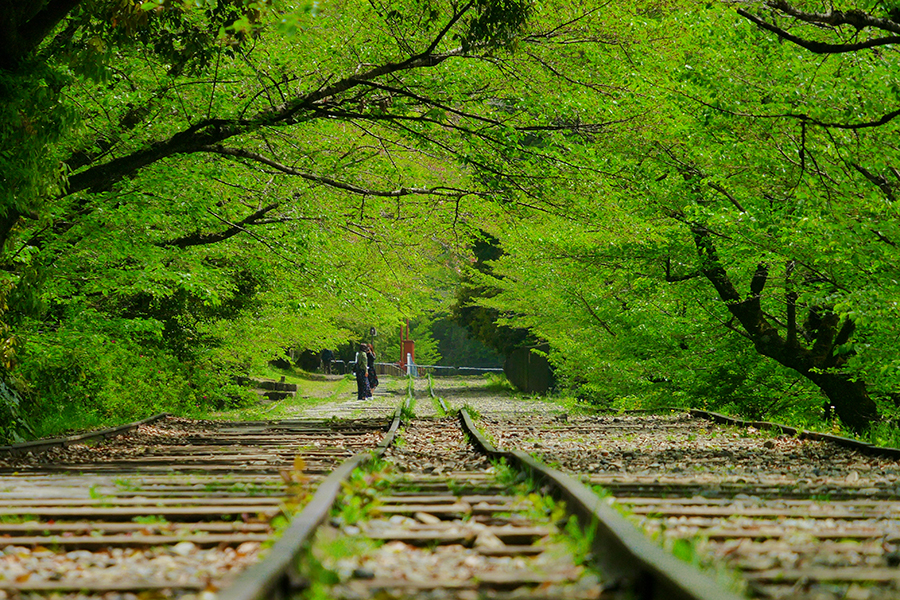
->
[[298, 418, 604, 600]]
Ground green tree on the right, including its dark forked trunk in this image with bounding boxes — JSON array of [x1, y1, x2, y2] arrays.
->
[[468, 3, 900, 430]]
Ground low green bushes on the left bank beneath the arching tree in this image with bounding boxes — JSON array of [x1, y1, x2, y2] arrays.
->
[[20, 310, 256, 435]]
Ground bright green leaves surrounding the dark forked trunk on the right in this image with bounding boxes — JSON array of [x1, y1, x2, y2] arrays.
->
[[446, 3, 900, 432]]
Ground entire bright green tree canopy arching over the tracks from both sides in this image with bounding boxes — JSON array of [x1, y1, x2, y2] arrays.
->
[[0, 0, 900, 437]]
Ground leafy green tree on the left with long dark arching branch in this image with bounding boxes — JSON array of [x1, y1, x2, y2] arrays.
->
[[0, 0, 620, 440]]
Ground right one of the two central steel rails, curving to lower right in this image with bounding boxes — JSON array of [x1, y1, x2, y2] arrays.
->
[[459, 408, 741, 600]]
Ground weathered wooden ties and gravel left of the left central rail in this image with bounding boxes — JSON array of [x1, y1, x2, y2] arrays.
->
[[0, 416, 390, 598]]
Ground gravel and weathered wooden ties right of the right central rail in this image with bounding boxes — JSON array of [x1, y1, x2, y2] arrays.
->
[[481, 406, 900, 600]]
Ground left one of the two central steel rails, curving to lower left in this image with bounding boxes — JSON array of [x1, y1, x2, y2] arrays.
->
[[217, 398, 409, 600]]
